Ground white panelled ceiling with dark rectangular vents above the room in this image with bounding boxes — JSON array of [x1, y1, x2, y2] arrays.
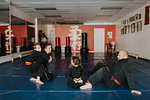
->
[[10, 0, 150, 24]]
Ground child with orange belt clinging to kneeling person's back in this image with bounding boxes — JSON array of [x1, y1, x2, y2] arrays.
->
[[25, 43, 41, 81]]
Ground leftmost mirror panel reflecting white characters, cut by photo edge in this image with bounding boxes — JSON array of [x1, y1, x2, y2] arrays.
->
[[0, 0, 10, 56]]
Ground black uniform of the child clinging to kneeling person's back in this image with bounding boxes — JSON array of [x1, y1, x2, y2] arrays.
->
[[26, 50, 41, 78]]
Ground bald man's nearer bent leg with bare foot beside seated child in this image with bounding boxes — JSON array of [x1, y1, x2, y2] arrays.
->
[[80, 67, 106, 90]]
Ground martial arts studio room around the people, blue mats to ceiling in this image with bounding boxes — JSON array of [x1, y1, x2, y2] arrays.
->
[[0, 0, 150, 100]]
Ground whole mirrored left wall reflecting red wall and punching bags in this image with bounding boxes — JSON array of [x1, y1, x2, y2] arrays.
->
[[0, 0, 35, 56]]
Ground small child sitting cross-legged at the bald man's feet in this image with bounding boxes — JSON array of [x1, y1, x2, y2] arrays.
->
[[66, 56, 88, 88]]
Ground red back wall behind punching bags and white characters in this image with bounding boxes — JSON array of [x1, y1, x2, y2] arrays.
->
[[55, 25, 116, 51]]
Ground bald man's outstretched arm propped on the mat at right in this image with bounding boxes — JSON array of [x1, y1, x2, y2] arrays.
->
[[123, 64, 142, 95]]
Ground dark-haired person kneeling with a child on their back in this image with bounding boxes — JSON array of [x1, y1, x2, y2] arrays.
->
[[35, 43, 52, 84]]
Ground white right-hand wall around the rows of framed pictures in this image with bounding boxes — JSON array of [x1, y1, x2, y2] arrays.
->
[[116, 4, 150, 59]]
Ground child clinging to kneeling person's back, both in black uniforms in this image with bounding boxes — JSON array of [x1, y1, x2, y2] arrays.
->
[[26, 43, 53, 84]]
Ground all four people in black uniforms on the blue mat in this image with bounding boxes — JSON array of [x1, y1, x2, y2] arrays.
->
[[26, 43, 141, 95]]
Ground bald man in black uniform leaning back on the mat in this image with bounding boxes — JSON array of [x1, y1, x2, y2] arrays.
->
[[80, 51, 141, 95]]
